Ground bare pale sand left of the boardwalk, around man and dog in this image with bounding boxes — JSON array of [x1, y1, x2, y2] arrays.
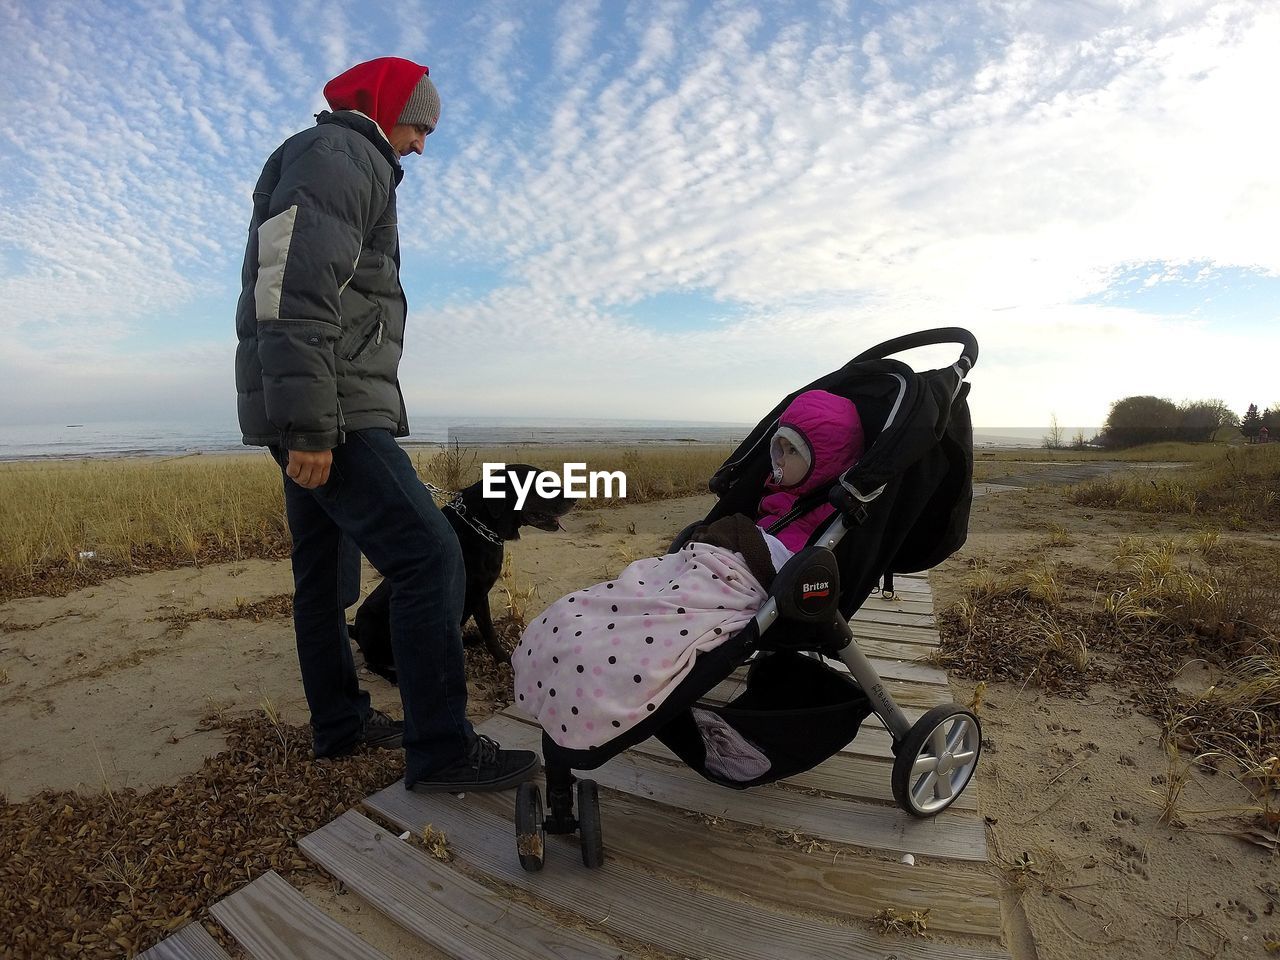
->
[[0, 497, 713, 801]]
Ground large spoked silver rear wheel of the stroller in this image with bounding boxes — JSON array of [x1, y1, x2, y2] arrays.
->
[[893, 704, 982, 817]]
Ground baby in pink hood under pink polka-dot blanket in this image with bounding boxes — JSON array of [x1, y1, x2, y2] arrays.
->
[[512, 390, 864, 750]]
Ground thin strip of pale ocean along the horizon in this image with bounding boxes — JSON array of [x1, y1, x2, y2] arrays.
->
[[0, 417, 1097, 461]]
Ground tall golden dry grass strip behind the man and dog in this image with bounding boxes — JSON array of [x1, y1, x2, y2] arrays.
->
[[0, 444, 728, 599]]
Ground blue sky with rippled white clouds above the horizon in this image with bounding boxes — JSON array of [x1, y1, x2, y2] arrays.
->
[[0, 0, 1280, 428]]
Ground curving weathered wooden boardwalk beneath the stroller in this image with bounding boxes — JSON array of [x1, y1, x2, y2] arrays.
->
[[146, 576, 1009, 960]]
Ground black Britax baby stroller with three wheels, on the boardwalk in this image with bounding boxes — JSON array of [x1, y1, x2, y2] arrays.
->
[[516, 328, 982, 870]]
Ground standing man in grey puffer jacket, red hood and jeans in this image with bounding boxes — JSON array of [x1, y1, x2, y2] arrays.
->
[[236, 56, 538, 791]]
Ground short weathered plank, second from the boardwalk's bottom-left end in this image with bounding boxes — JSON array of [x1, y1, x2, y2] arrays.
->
[[209, 870, 387, 960]]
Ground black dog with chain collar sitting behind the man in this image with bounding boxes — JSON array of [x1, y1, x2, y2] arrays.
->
[[347, 463, 573, 684]]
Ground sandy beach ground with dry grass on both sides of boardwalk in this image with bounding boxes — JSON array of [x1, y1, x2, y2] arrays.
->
[[0, 448, 1280, 960]]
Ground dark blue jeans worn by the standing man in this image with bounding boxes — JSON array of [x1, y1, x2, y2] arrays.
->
[[271, 430, 475, 783]]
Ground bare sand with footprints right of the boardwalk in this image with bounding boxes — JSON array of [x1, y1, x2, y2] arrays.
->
[[931, 477, 1280, 960]]
